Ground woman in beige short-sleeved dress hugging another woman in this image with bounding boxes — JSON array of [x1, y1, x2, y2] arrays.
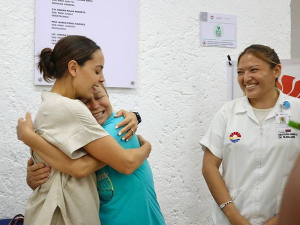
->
[[17, 35, 151, 225]]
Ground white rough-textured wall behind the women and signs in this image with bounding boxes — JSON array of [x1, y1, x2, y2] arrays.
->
[[0, 0, 291, 225]]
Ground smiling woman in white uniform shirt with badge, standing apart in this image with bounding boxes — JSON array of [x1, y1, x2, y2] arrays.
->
[[200, 45, 300, 225]]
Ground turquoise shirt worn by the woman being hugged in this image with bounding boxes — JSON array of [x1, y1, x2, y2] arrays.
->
[[96, 114, 165, 225]]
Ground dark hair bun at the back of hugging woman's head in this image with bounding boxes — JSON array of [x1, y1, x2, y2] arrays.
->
[[38, 48, 55, 81]]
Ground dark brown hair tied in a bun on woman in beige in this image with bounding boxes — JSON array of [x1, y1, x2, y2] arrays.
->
[[38, 35, 101, 82]]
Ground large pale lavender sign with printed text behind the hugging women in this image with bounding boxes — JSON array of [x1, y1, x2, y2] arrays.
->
[[35, 0, 138, 88]]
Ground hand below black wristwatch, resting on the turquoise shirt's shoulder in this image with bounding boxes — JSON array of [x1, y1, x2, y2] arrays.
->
[[115, 109, 138, 141]]
